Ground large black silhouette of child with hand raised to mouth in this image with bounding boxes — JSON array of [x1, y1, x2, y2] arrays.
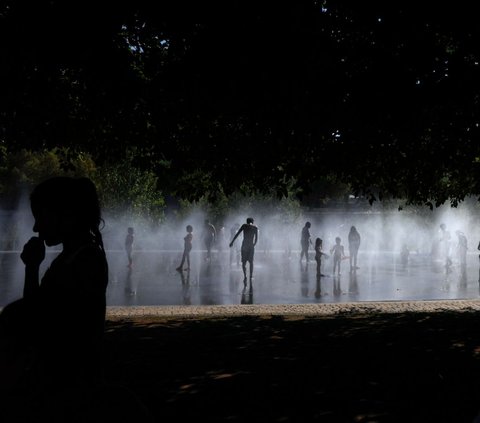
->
[[0, 177, 108, 421]]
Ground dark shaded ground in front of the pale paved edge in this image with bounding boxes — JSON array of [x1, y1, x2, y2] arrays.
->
[[106, 311, 480, 423]]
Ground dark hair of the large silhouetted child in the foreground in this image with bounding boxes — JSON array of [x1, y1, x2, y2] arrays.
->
[[30, 176, 105, 251]]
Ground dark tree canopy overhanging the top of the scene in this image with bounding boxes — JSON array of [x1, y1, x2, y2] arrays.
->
[[0, 0, 480, 207]]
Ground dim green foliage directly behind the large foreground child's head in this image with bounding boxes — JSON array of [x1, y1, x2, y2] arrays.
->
[[0, 148, 165, 224]]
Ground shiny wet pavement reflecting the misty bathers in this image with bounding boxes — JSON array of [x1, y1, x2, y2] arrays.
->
[[0, 250, 480, 307]]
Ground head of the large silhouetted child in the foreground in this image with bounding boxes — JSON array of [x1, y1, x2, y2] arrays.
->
[[30, 176, 103, 246]]
